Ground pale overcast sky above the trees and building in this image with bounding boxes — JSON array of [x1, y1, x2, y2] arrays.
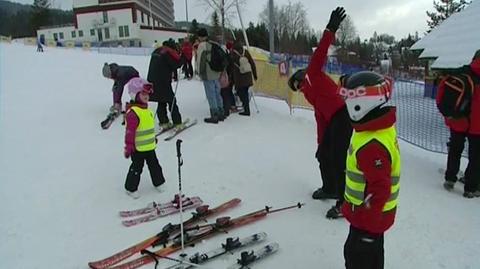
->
[[14, 0, 433, 39]]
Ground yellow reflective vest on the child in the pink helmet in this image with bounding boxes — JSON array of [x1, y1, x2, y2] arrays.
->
[[130, 106, 156, 152]]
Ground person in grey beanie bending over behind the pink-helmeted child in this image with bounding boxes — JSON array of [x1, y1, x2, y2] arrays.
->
[[102, 63, 139, 113]]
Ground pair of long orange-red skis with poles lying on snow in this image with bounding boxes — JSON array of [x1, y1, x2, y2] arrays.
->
[[88, 199, 303, 269]]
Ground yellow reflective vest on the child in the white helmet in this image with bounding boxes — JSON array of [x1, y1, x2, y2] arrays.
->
[[345, 126, 401, 212]]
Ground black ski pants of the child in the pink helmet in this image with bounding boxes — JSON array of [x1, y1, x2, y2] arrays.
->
[[125, 150, 165, 192]]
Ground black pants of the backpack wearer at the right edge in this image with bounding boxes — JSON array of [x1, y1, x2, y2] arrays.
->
[[445, 130, 480, 192]]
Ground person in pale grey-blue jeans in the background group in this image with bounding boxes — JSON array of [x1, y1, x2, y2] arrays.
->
[[195, 28, 225, 123]]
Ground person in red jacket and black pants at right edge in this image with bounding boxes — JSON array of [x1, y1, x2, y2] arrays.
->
[[437, 50, 480, 198]]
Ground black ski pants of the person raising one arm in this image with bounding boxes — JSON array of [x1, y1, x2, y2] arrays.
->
[[315, 106, 352, 201]]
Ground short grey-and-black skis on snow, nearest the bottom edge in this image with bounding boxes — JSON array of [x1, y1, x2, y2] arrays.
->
[[166, 233, 279, 269]]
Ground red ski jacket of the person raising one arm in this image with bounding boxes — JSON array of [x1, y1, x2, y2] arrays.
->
[[301, 29, 345, 144]]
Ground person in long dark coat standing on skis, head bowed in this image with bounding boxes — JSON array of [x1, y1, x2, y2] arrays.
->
[[147, 43, 182, 128]]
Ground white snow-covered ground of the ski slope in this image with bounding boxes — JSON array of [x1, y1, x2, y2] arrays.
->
[[0, 44, 480, 269]]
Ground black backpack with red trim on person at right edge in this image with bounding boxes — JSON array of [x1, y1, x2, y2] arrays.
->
[[437, 74, 475, 118]]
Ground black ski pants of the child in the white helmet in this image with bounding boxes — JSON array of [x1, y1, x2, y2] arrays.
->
[[343, 225, 384, 269]]
